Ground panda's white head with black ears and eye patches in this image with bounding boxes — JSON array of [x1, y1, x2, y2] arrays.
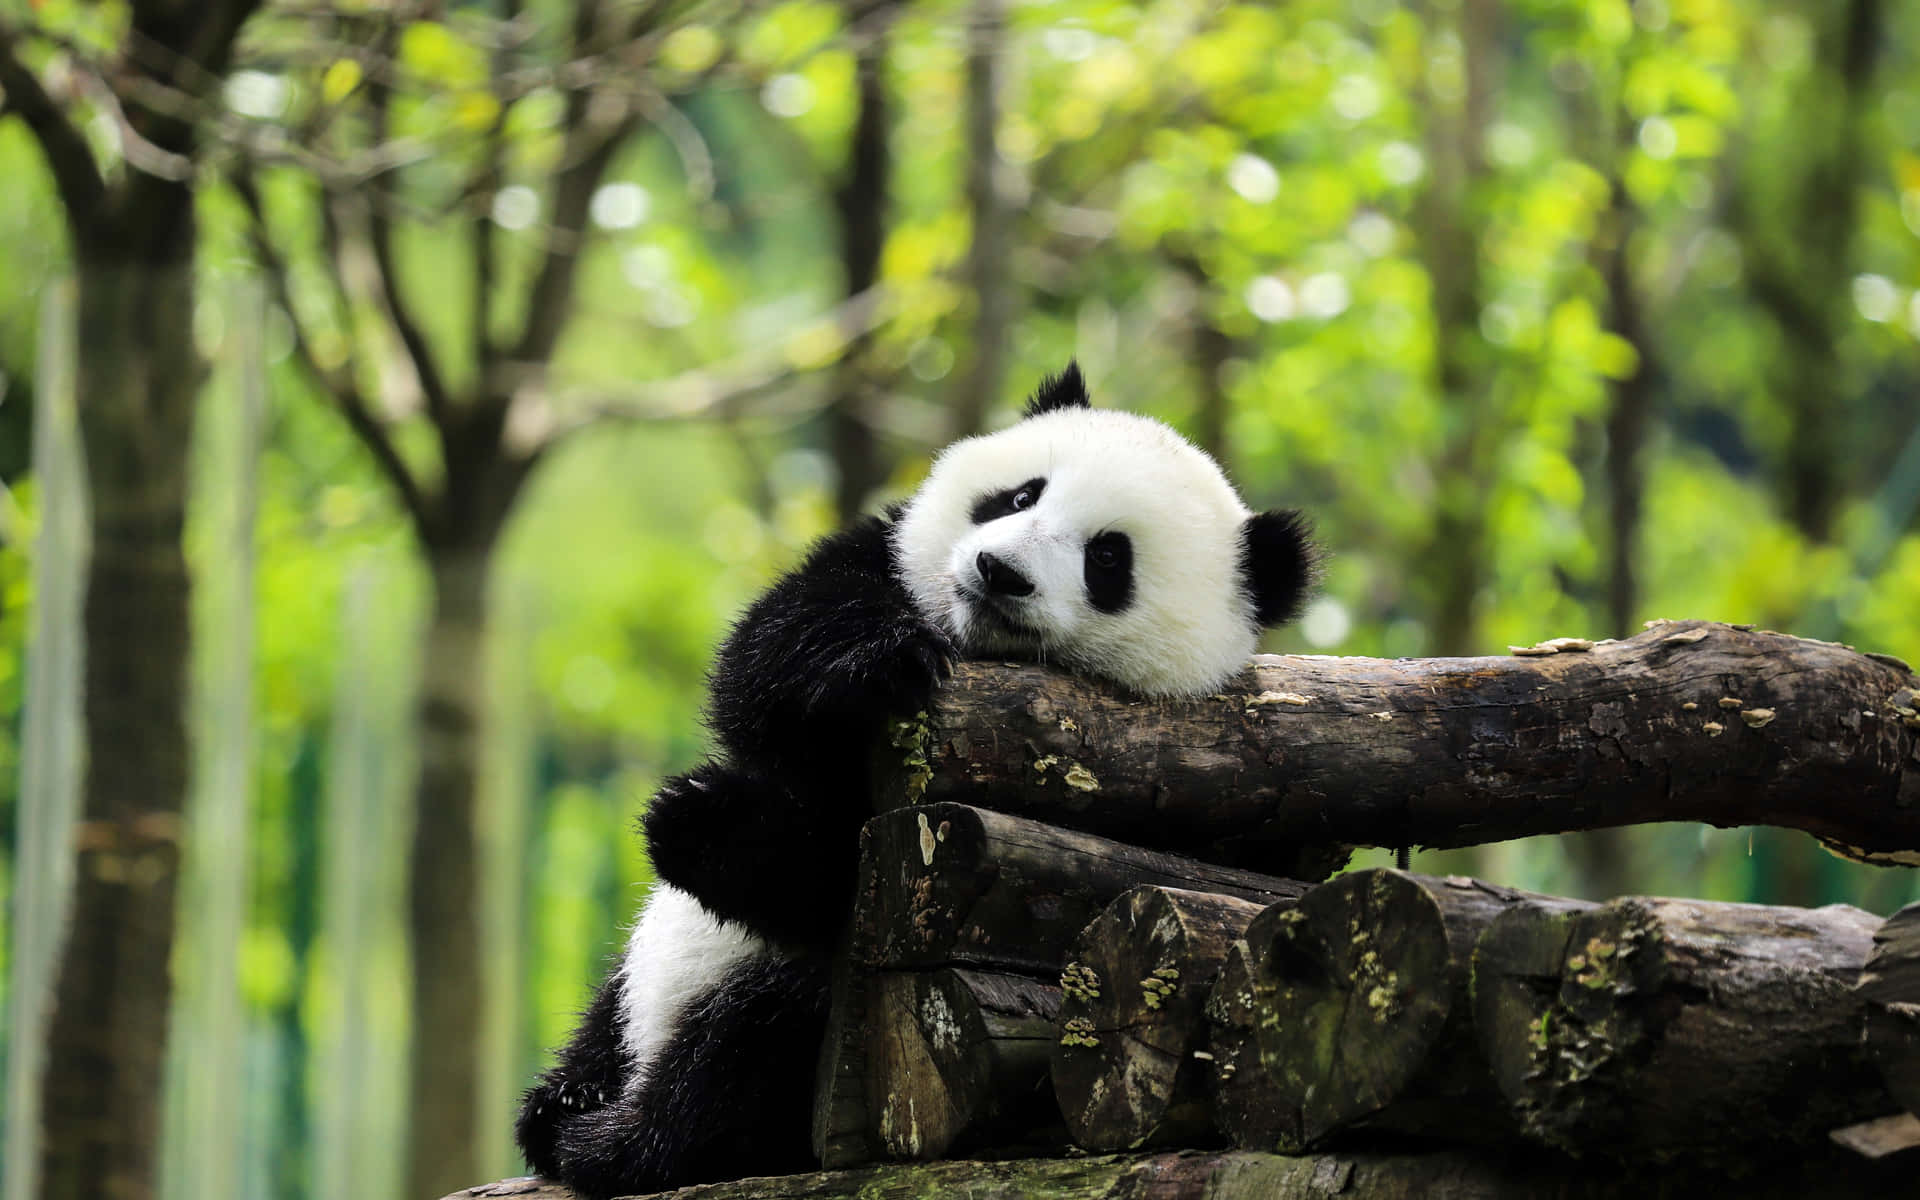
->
[[895, 365, 1313, 695]]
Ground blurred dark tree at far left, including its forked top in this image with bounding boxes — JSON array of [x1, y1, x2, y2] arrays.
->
[[0, 0, 257, 1200]]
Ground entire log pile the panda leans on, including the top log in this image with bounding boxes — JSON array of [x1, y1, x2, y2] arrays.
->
[[441, 622, 1920, 1200]]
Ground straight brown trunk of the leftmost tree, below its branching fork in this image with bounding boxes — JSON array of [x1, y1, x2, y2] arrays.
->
[[40, 249, 202, 1200]]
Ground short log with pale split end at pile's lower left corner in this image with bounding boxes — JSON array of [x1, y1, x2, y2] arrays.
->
[[866, 968, 1066, 1162]]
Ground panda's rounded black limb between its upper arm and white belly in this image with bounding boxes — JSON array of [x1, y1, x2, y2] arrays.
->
[[641, 762, 864, 948]]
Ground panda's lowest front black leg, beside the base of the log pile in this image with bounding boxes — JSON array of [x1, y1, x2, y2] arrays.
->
[[559, 958, 828, 1200]]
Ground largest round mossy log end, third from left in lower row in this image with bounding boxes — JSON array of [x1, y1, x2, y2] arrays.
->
[[1225, 870, 1578, 1152]]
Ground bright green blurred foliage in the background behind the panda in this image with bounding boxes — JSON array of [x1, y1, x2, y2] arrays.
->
[[11, 0, 1920, 1194]]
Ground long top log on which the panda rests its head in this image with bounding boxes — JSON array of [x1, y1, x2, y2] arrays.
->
[[877, 620, 1920, 874]]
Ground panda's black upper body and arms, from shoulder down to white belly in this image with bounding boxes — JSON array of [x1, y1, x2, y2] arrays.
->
[[641, 518, 954, 947]]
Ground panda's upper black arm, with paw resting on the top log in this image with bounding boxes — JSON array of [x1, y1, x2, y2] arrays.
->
[[707, 516, 954, 768]]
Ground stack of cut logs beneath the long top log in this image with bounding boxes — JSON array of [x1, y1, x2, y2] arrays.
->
[[816, 804, 1920, 1169]]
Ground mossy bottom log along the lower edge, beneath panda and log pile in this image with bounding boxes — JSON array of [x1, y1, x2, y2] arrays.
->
[[445, 1148, 1912, 1200]]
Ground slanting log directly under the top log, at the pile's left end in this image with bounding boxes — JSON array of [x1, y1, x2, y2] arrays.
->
[[852, 804, 1308, 979]]
